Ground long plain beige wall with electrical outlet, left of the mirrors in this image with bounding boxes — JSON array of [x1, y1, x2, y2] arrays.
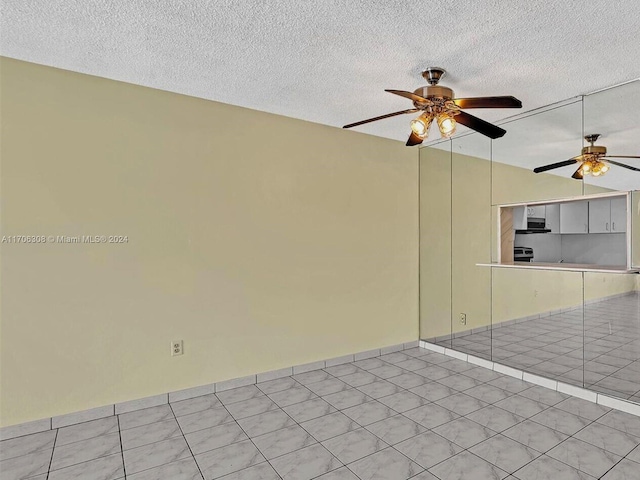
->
[[0, 59, 418, 425]]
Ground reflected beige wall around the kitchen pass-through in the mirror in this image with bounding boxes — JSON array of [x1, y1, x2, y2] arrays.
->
[[420, 144, 640, 338]]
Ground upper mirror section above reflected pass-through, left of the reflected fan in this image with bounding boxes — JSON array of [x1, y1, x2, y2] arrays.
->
[[492, 99, 582, 205]]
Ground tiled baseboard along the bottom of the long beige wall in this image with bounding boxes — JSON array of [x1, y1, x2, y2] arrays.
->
[[0, 340, 419, 440]]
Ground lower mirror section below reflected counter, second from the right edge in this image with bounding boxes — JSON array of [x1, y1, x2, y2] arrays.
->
[[492, 268, 583, 386]]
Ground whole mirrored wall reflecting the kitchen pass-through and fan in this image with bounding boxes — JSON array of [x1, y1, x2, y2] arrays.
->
[[420, 81, 640, 402]]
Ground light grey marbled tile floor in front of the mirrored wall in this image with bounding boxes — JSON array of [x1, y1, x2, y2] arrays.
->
[[0, 348, 640, 480]]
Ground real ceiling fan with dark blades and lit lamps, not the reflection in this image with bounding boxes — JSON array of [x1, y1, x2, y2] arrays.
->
[[342, 67, 522, 146]]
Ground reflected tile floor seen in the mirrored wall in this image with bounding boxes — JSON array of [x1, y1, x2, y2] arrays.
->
[[438, 295, 640, 404]]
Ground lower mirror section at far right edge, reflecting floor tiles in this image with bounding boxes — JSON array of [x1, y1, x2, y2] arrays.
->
[[584, 272, 640, 403]]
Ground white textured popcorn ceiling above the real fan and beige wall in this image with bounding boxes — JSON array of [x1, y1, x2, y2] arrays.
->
[[0, 0, 640, 160]]
